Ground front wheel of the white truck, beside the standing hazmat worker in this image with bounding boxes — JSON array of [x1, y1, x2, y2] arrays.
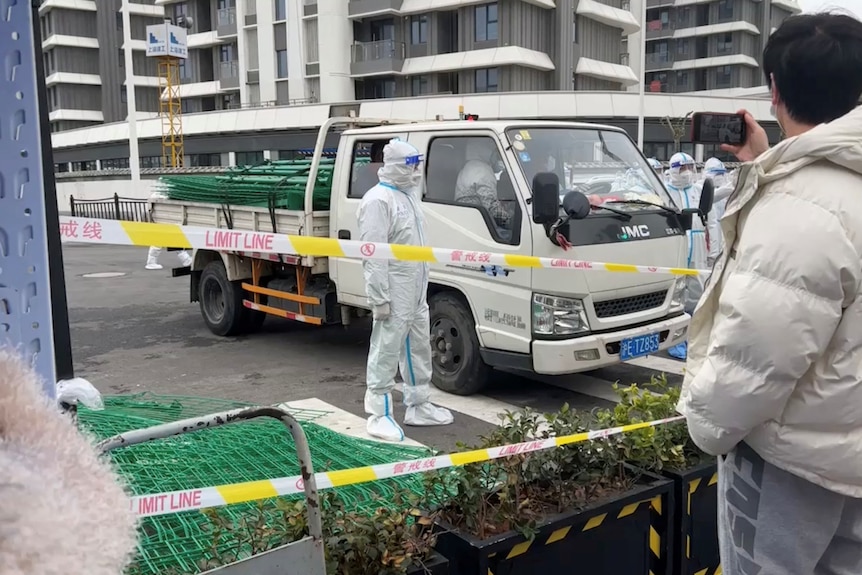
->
[[429, 293, 491, 395]]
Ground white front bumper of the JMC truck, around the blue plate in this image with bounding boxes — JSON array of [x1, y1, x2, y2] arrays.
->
[[532, 314, 691, 375]]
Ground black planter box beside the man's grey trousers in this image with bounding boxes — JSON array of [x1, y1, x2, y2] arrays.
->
[[664, 462, 721, 575]]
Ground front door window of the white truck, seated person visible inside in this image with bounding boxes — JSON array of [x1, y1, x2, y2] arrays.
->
[[423, 136, 521, 245]]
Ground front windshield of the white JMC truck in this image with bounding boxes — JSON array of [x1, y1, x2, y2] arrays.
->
[[506, 127, 676, 213]]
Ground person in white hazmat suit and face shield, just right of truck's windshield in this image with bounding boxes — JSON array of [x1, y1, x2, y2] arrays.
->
[[667, 152, 718, 359]]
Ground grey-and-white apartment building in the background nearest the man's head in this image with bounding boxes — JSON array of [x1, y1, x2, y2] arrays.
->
[[644, 0, 801, 92]]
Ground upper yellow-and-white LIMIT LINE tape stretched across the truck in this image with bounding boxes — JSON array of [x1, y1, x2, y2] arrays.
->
[[60, 216, 710, 276]]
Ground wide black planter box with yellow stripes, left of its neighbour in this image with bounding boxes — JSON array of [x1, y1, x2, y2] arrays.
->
[[435, 474, 674, 575]]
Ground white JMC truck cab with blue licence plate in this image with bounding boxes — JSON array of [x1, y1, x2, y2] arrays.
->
[[329, 121, 690, 394]]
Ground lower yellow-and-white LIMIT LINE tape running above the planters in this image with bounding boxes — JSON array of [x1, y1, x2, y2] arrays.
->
[[130, 416, 684, 517]]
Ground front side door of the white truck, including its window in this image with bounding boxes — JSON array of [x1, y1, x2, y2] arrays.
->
[[408, 129, 532, 360]]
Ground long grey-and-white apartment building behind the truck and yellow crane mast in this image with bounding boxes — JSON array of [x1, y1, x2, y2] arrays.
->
[[40, 0, 640, 131]]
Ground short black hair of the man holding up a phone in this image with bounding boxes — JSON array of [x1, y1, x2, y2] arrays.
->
[[763, 13, 862, 125]]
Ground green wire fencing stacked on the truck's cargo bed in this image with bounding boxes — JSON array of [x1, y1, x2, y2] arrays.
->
[[158, 158, 368, 210]]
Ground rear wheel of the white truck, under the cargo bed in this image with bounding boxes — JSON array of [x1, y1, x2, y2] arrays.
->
[[198, 260, 246, 336]]
